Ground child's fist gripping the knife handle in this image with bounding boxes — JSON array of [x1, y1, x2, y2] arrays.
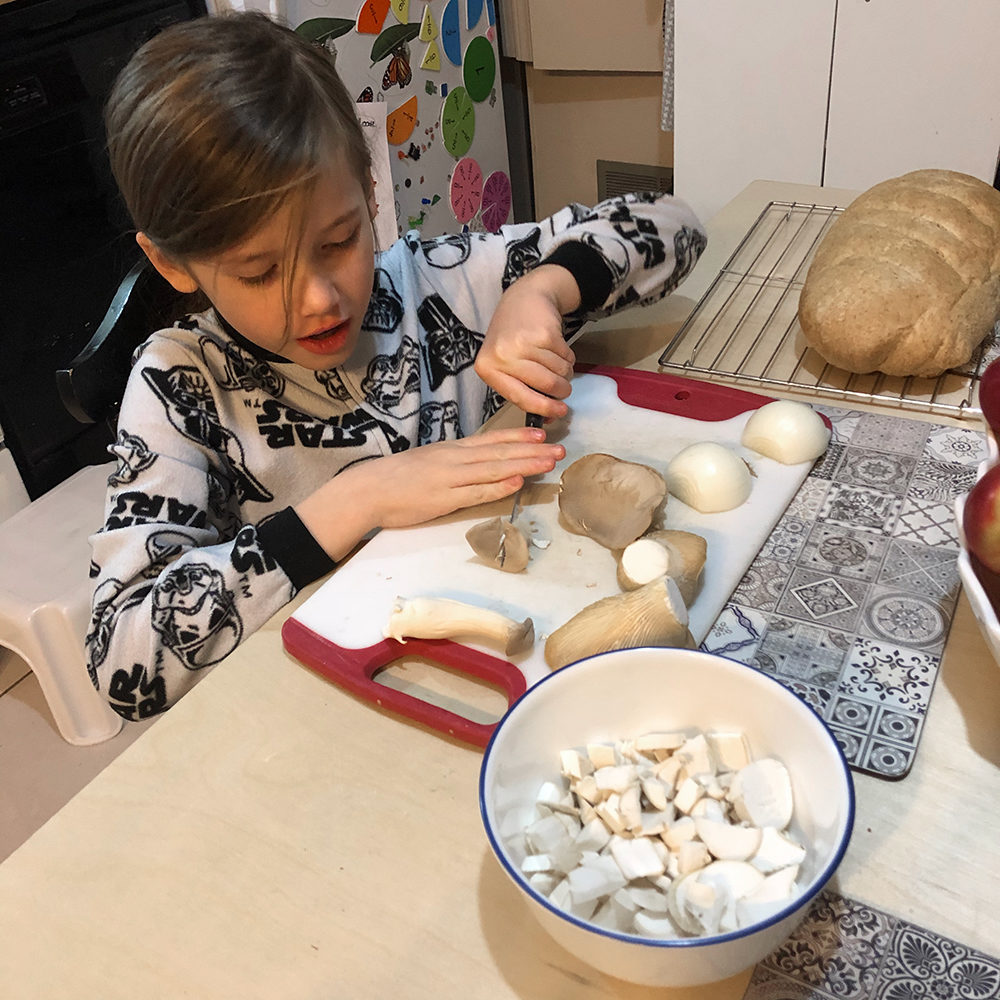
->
[[476, 264, 580, 417]]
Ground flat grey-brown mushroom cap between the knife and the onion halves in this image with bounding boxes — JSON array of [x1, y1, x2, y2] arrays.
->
[[559, 452, 667, 549]]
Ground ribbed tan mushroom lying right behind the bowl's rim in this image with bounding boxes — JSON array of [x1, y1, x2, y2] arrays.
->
[[545, 576, 694, 670]]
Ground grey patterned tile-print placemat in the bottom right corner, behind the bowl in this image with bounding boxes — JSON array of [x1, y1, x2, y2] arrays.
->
[[743, 890, 1000, 1000]]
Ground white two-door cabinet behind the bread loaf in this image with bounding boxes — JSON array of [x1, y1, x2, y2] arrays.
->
[[674, 0, 1000, 225]]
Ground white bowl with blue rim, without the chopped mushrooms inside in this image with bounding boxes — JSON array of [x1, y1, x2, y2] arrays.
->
[[479, 648, 854, 987]]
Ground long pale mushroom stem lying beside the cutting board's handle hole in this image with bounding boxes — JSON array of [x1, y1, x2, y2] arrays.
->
[[385, 597, 535, 656]]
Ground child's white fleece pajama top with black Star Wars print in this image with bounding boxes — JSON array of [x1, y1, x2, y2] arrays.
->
[[87, 195, 705, 719]]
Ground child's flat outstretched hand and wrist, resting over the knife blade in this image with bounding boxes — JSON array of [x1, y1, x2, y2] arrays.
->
[[295, 427, 566, 559]]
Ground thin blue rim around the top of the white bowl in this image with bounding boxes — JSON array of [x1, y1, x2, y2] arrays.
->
[[479, 646, 855, 948]]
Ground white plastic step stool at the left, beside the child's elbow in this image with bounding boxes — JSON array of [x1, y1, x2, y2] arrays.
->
[[0, 462, 122, 746]]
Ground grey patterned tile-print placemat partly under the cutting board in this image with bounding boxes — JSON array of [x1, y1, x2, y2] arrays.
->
[[701, 406, 986, 779]]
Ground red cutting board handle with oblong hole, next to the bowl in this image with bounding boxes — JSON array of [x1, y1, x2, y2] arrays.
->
[[281, 618, 527, 747]]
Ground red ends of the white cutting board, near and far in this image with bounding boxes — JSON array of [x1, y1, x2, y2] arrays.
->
[[281, 364, 830, 748]]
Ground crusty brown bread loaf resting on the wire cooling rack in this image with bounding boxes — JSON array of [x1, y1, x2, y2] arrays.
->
[[799, 170, 1000, 376]]
